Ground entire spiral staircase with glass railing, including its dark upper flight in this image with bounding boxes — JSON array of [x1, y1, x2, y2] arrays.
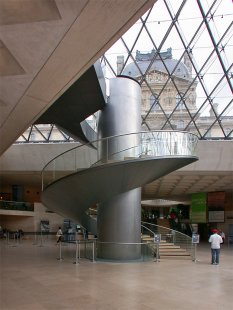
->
[[38, 63, 198, 234]]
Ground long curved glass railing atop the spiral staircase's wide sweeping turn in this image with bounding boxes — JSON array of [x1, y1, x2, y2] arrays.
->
[[42, 131, 198, 189]]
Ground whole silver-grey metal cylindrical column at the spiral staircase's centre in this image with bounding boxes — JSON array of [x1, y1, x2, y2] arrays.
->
[[97, 77, 141, 260]]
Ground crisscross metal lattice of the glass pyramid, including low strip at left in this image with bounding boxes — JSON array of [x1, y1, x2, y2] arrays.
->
[[17, 0, 233, 143]]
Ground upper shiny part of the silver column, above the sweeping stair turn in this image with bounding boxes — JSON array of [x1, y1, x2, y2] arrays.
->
[[97, 77, 141, 159]]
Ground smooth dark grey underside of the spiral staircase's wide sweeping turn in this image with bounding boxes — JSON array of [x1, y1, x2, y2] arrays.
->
[[42, 156, 197, 234]]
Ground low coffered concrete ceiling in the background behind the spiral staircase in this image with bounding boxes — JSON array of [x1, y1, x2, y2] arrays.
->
[[1, 168, 233, 206]]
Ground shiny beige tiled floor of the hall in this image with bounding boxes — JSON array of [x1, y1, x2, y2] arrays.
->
[[0, 240, 233, 310]]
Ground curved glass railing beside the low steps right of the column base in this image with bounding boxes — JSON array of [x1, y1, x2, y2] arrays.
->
[[142, 222, 194, 258]]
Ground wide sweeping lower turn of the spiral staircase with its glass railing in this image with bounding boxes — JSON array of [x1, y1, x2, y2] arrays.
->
[[42, 131, 198, 234]]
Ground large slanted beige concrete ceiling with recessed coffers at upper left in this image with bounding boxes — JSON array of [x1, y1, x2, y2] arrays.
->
[[0, 0, 156, 155]]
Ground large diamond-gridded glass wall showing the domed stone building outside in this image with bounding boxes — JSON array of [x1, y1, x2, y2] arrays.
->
[[104, 0, 233, 138]]
